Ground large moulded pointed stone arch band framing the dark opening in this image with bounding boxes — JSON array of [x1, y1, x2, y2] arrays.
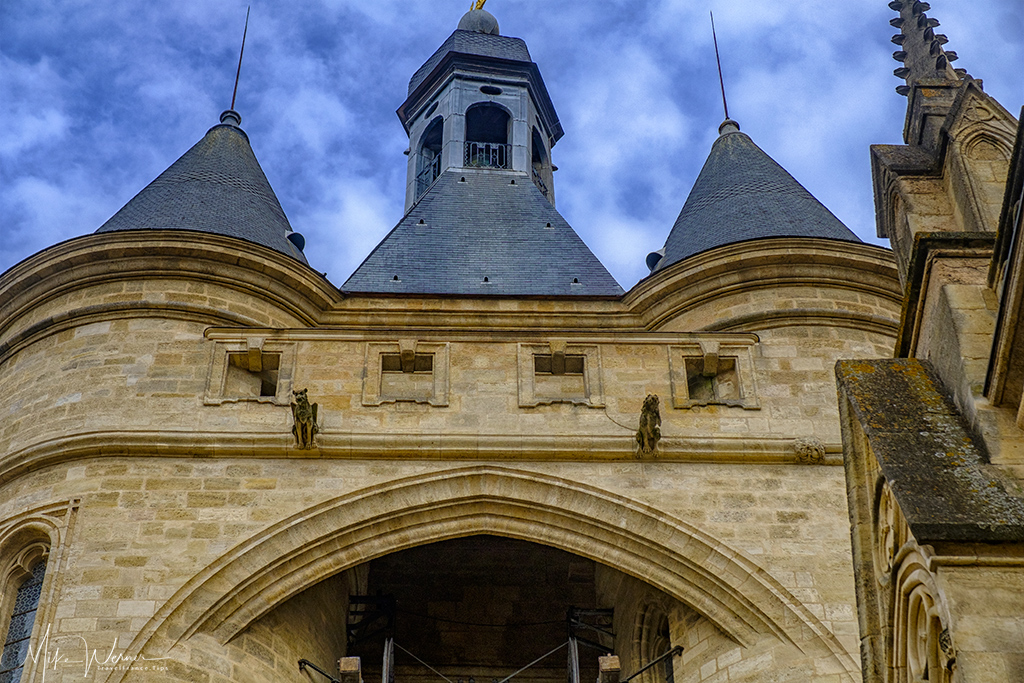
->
[[108, 466, 857, 683]]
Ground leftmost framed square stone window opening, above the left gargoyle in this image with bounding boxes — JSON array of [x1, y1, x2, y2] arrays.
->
[[203, 337, 296, 405]]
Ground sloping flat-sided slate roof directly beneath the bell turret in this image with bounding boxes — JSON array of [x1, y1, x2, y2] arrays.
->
[[342, 169, 623, 296]]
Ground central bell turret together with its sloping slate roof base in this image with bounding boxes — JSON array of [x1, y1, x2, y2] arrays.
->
[[342, 7, 623, 297]]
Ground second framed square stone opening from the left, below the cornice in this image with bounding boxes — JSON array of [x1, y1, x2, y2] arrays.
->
[[362, 339, 450, 407]]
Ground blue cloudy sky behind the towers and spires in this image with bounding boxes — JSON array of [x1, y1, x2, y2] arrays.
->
[[0, 0, 1024, 289]]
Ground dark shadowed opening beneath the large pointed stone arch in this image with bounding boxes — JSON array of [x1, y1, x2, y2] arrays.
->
[[264, 535, 695, 683]]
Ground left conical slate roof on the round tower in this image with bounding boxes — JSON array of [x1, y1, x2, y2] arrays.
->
[[96, 113, 306, 263]]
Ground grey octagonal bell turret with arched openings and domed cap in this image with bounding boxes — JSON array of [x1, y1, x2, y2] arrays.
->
[[397, 9, 562, 213]]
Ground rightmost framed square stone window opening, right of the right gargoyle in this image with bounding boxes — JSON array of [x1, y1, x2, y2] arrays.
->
[[669, 339, 761, 411]]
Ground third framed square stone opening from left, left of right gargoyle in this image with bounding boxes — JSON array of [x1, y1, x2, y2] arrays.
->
[[518, 340, 604, 408]]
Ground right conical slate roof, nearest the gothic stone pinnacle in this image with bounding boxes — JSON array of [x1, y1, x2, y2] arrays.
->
[[648, 121, 860, 270]]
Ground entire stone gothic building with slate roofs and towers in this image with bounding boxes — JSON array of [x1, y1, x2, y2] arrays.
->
[[0, 2, 1024, 683]]
